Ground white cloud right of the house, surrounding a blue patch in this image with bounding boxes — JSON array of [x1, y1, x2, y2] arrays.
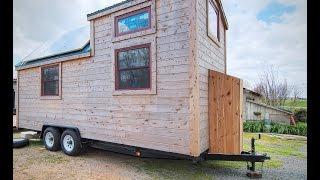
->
[[224, 0, 307, 97]]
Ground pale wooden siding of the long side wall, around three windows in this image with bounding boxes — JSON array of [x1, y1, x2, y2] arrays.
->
[[19, 0, 191, 155]]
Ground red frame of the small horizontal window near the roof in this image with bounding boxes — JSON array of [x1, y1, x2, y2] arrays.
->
[[114, 6, 151, 37]]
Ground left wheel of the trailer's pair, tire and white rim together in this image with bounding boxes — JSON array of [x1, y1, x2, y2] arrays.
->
[[43, 127, 61, 151]]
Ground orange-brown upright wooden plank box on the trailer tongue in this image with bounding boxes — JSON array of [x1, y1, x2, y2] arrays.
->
[[208, 70, 243, 154]]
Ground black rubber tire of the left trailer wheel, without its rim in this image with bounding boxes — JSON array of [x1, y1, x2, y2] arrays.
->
[[42, 127, 61, 151]]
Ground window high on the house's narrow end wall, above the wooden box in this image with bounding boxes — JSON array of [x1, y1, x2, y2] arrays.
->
[[208, 0, 220, 41]]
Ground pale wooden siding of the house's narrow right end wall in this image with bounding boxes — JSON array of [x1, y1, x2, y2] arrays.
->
[[196, 0, 226, 152]]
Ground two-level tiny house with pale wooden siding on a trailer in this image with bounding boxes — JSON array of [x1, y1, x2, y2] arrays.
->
[[16, 0, 242, 157]]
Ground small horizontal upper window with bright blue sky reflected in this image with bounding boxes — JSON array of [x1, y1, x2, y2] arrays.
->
[[115, 7, 151, 36]]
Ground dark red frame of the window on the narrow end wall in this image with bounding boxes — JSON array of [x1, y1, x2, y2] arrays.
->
[[207, 0, 220, 45]]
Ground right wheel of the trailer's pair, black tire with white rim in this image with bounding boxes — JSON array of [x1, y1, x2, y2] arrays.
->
[[61, 129, 82, 156]]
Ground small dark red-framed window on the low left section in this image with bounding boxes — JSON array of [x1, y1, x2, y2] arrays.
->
[[41, 65, 59, 96]]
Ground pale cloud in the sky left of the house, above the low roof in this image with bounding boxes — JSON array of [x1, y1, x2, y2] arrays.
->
[[13, 0, 122, 76]]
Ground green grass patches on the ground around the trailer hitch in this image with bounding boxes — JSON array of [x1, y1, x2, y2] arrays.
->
[[135, 133, 306, 179]]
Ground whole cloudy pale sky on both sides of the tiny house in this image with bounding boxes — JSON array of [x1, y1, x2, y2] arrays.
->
[[13, 0, 307, 97]]
